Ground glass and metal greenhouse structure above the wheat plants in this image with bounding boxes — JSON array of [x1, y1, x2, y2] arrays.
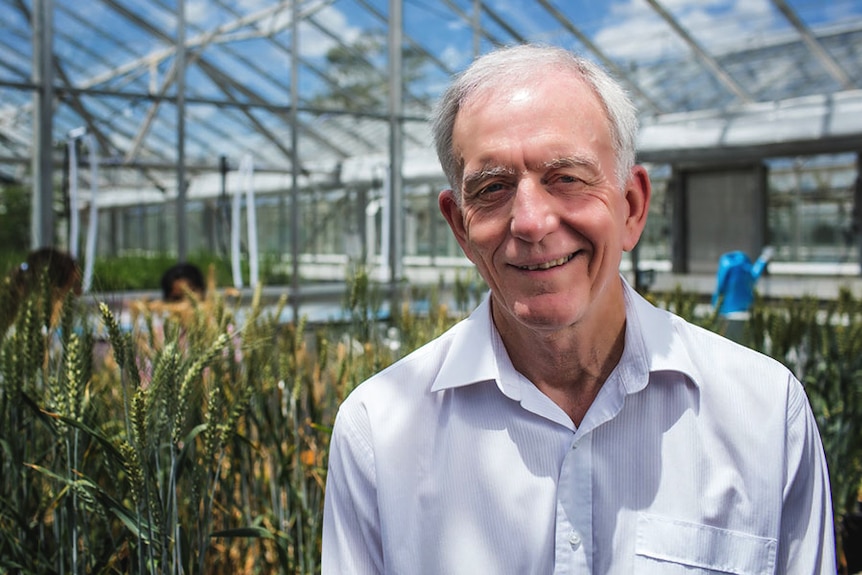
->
[[5, 0, 862, 292]]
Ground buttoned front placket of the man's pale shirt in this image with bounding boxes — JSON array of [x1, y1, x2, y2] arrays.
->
[[554, 433, 593, 575]]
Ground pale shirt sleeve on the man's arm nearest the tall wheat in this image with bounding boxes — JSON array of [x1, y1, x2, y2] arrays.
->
[[322, 404, 383, 575]]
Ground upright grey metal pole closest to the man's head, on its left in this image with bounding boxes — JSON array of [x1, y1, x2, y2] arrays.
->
[[389, 0, 404, 318]]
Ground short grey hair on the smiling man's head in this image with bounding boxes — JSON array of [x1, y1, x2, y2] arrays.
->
[[431, 44, 638, 202]]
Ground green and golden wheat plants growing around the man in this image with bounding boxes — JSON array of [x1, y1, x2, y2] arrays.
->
[[0, 269, 862, 574]]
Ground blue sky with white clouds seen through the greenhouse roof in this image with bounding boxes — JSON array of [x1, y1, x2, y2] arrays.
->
[[5, 0, 862, 171]]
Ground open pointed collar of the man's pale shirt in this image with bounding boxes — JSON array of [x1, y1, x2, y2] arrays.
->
[[431, 277, 701, 400]]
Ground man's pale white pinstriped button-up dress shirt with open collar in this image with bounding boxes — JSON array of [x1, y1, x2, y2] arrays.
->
[[322, 276, 836, 575]]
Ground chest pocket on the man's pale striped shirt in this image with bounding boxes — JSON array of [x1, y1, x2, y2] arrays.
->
[[635, 513, 778, 575]]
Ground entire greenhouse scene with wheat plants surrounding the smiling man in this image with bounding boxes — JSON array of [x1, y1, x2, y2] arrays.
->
[[0, 0, 862, 574]]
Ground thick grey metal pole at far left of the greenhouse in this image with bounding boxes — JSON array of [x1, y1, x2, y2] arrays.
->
[[30, 0, 54, 249]]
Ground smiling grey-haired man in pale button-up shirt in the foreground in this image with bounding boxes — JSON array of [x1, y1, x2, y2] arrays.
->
[[322, 45, 836, 575]]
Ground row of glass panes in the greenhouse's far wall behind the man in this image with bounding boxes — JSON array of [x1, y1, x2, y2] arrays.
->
[[82, 154, 858, 276]]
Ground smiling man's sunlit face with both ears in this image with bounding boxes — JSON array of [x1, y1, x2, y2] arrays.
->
[[440, 73, 649, 331]]
